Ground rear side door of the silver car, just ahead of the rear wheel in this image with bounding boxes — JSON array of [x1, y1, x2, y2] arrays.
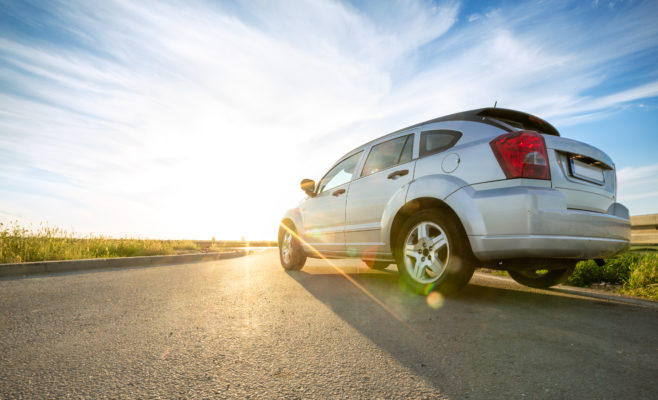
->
[[345, 132, 415, 255]]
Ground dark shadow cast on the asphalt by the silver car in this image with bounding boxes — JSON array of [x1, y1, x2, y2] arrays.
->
[[288, 266, 658, 398]]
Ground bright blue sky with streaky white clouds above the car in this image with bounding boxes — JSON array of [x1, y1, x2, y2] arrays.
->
[[0, 0, 658, 240]]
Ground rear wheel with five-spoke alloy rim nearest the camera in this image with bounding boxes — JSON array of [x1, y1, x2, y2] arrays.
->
[[395, 209, 474, 295]]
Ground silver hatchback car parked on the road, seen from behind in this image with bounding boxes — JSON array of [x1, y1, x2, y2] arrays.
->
[[278, 107, 631, 295]]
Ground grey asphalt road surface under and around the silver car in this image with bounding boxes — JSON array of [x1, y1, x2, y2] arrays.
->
[[0, 250, 658, 399]]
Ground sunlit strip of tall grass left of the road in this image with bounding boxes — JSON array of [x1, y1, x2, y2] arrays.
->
[[0, 222, 271, 263]]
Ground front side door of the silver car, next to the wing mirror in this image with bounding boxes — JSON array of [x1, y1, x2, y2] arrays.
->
[[300, 151, 363, 256]]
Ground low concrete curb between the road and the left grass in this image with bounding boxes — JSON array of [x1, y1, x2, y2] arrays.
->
[[0, 250, 251, 278]]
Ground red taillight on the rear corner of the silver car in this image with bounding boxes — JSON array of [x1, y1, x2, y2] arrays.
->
[[489, 131, 551, 180]]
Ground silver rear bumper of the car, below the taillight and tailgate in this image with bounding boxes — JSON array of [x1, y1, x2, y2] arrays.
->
[[446, 185, 631, 261]]
